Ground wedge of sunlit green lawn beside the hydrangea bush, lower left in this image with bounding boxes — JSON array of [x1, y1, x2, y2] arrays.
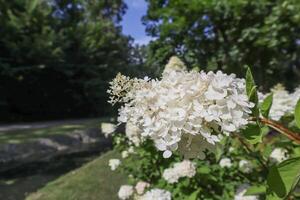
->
[[26, 151, 127, 200]]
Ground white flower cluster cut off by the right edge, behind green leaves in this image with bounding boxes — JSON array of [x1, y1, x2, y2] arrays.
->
[[259, 84, 300, 121]]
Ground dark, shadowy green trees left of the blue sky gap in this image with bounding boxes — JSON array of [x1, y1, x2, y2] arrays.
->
[[0, 0, 137, 121]]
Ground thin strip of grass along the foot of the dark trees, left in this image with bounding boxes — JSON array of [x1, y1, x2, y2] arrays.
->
[[0, 119, 107, 144]]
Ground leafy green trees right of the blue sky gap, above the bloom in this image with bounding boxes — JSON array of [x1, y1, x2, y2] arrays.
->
[[143, 0, 300, 89]]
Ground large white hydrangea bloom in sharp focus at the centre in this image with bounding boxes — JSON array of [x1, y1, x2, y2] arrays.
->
[[110, 58, 253, 158]]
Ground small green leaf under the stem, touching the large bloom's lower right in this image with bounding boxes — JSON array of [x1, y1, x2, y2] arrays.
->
[[241, 124, 262, 144]]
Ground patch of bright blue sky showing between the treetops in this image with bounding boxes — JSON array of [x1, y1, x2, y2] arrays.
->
[[121, 0, 151, 44]]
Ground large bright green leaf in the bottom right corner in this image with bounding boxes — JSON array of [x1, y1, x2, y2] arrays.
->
[[267, 157, 300, 199]]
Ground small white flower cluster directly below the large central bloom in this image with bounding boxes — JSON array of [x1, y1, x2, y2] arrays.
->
[[163, 160, 196, 183]]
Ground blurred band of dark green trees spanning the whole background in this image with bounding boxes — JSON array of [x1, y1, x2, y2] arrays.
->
[[0, 0, 300, 121]]
